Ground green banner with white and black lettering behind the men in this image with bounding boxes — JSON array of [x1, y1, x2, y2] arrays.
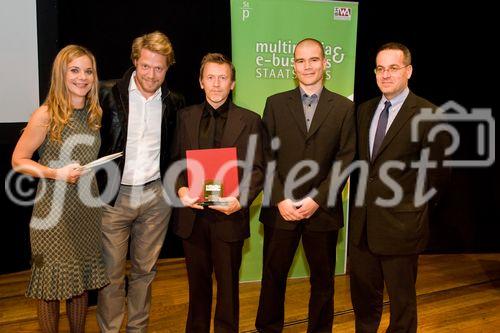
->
[[231, 0, 358, 281]]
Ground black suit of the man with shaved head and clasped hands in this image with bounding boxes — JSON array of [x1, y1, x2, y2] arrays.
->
[[256, 88, 356, 332]]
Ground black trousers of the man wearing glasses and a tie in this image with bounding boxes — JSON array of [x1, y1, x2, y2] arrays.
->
[[349, 233, 418, 333]]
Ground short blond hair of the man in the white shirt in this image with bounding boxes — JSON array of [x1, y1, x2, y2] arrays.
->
[[130, 31, 175, 67]]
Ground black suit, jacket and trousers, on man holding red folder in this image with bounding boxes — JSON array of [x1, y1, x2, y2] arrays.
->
[[174, 103, 264, 332]]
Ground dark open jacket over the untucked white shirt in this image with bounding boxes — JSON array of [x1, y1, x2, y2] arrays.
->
[[97, 67, 185, 202]]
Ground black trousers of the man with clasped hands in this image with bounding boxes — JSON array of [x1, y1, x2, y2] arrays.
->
[[255, 224, 338, 333]]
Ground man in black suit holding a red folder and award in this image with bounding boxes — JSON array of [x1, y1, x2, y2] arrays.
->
[[174, 53, 264, 333]]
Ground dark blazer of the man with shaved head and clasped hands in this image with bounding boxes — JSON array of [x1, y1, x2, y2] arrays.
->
[[260, 88, 356, 231]]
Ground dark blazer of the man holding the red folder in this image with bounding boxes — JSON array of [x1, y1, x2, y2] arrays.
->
[[173, 102, 264, 242]]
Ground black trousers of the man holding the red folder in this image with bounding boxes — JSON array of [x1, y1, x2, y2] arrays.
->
[[183, 214, 243, 333]]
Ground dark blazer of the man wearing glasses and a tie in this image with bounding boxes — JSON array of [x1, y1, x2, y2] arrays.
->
[[349, 92, 449, 255]]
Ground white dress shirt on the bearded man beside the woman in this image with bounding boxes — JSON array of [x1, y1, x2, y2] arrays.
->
[[122, 72, 162, 185]]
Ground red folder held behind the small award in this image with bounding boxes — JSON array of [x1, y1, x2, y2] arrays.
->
[[186, 147, 239, 201]]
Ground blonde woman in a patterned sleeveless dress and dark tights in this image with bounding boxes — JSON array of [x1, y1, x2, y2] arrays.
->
[[12, 45, 108, 332]]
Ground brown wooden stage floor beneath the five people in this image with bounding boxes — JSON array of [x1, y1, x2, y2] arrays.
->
[[0, 254, 500, 333]]
